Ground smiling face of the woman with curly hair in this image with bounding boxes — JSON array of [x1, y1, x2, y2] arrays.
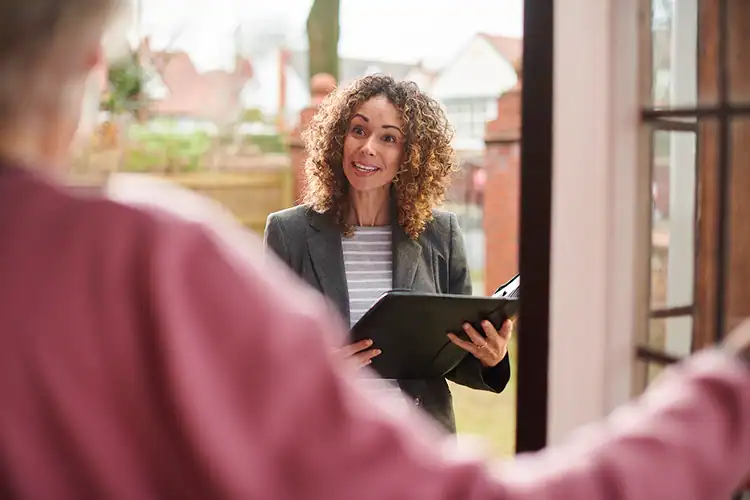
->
[[343, 96, 405, 191]]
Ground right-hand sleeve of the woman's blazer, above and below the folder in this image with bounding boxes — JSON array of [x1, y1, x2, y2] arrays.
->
[[446, 214, 510, 393]]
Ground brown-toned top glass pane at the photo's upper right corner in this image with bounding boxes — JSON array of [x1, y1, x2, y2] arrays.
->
[[726, 0, 750, 104]]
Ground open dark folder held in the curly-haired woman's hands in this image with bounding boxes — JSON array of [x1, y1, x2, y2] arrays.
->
[[350, 287, 518, 380]]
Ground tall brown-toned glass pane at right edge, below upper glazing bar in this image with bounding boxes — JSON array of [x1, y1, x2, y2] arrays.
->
[[724, 117, 750, 332]]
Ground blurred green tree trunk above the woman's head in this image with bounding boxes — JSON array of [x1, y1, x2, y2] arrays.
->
[[307, 0, 340, 81]]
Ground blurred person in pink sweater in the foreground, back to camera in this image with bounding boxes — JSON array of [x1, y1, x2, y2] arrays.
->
[[0, 0, 750, 500]]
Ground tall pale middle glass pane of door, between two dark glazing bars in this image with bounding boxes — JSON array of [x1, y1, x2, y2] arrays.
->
[[651, 130, 696, 309]]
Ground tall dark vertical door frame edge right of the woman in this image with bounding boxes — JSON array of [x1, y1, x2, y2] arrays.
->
[[516, 0, 554, 453]]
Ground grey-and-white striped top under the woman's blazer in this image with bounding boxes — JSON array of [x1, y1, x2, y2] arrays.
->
[[342, 226, 393, 326]]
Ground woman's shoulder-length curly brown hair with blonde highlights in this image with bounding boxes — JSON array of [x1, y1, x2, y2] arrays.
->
[[303, 75, 457, 239]]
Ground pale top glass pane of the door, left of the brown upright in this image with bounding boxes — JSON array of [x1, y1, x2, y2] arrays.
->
[[651, 0, 704, 108]]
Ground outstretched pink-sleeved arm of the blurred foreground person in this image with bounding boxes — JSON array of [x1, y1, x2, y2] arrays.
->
[[149, 221, 750, 500]]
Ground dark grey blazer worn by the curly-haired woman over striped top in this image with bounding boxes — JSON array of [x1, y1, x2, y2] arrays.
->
[[264, 206, 510, 432]]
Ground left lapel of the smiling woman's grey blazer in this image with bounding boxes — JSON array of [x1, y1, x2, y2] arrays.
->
[[307, 211, 350, 324]]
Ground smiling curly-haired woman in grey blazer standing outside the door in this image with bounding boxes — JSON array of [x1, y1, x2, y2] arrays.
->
[[265, 75, 510, 432]]
